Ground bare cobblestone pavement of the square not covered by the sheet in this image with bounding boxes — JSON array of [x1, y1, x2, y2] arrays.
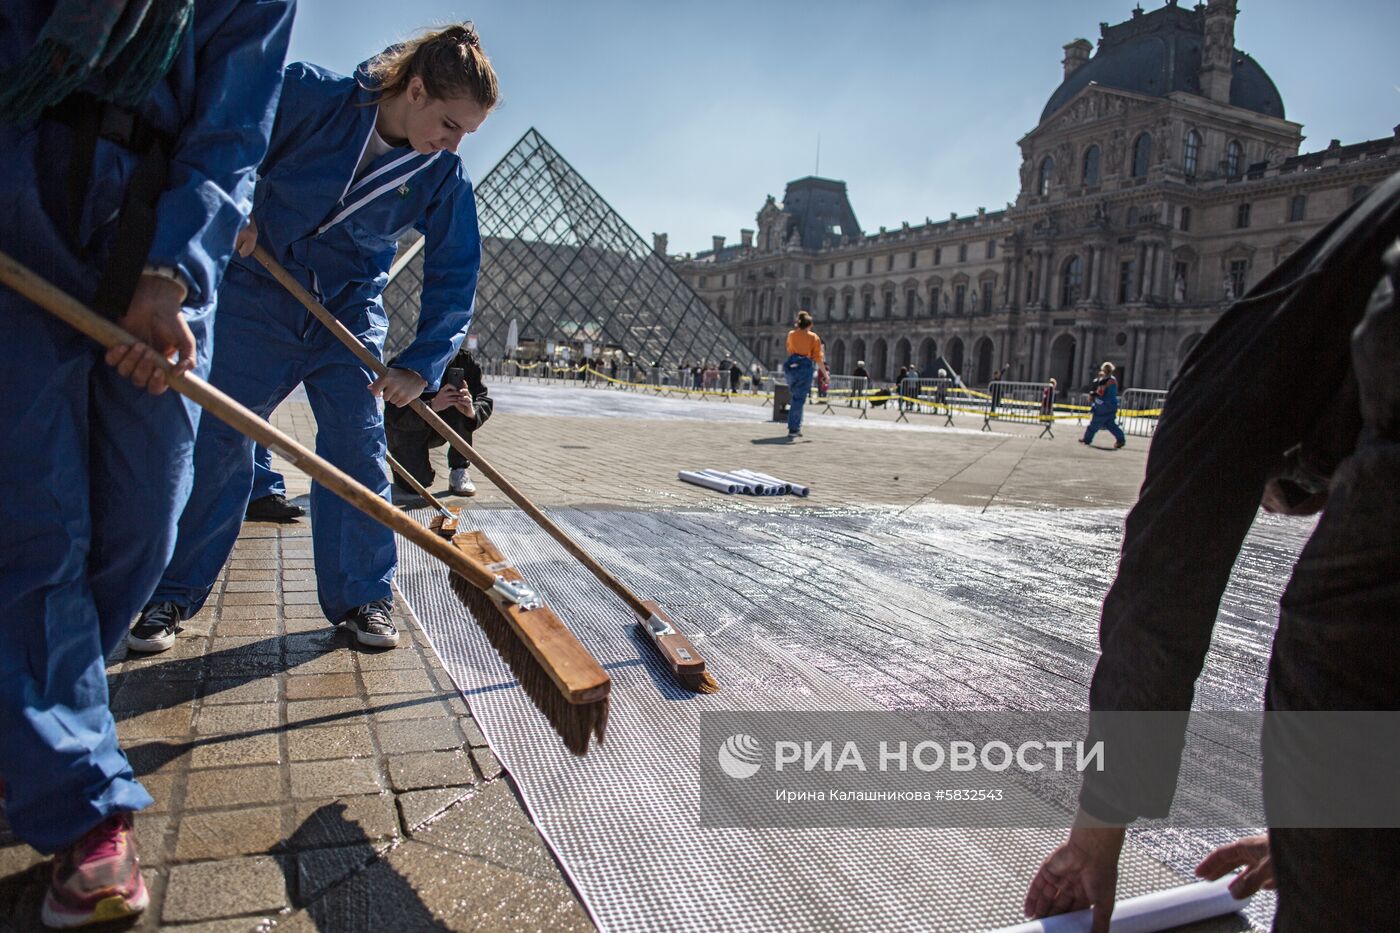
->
[[0, 375, 1147, 932]]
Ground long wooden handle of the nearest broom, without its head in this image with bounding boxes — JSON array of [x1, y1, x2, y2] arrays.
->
[[0, 252, 496, 590]]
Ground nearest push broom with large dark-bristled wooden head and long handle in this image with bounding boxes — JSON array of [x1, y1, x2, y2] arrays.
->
[[0, 252, 612, 755]]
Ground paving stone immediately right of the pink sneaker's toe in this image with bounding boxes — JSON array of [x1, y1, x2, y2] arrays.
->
[[161, 856, 287, 923]]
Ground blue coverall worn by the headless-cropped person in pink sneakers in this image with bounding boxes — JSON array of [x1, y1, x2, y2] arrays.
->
[[0, 0, 293, 852]]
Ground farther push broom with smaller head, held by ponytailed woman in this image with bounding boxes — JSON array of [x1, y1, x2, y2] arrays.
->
[[253, 245, 720, 693]]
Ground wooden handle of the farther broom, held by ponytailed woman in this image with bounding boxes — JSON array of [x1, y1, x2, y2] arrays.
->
[[253, 244, 651, 619]]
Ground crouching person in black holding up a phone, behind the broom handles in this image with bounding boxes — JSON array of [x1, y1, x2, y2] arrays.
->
[[384, 343, 491, 496]]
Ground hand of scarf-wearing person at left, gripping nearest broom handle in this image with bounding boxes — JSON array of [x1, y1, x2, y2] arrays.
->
[[105, 275, 195, 395]]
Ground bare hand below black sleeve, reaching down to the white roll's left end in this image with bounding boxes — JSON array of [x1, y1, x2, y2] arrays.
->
[[1025, 811, 1124, 933]]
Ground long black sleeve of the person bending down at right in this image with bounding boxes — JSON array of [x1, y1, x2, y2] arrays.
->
[[1079, 175, 1400, 820]]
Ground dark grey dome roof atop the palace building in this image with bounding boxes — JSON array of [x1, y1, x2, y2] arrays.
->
[[1040, 3, 1284, 123]]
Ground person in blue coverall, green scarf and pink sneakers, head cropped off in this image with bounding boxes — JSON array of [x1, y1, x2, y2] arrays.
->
[[0, 0, 293, 927]]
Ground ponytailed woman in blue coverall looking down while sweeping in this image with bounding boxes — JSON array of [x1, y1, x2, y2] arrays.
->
[[127, 24, 498, 651]]
